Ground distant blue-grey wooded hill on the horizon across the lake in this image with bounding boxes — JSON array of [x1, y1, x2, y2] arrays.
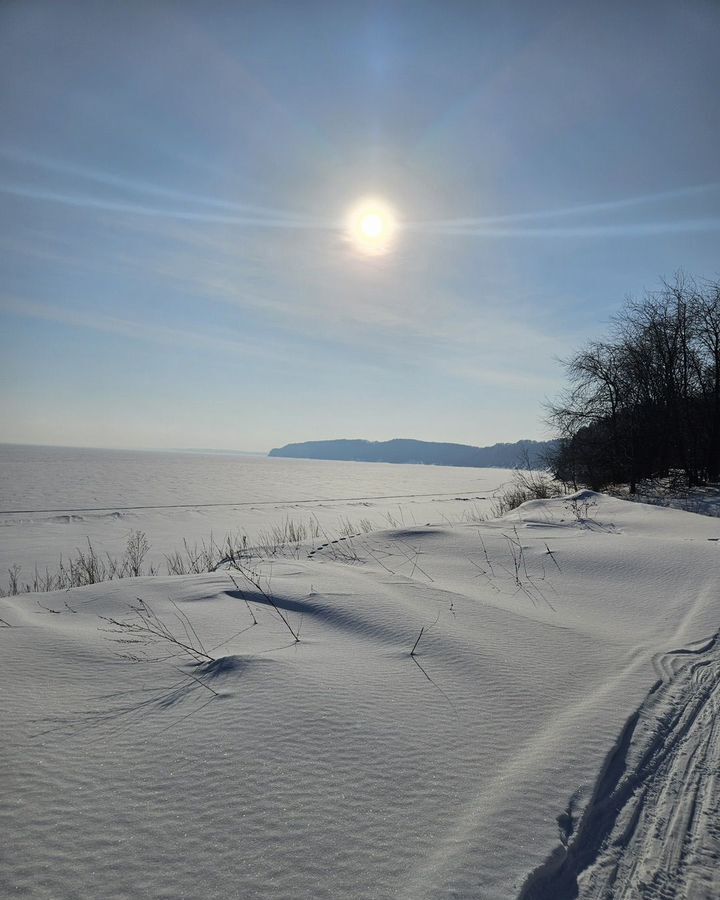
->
[[268, 438, 557, 469]]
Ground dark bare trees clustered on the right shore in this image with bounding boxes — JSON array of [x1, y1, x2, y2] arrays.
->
[[548, 274, 720, 493]]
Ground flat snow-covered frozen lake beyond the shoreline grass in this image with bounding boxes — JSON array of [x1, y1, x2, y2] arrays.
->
[[0, 444, 511, 584]]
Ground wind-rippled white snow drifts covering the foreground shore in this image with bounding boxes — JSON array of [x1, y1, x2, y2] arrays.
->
[[0, 492, 720, 900]]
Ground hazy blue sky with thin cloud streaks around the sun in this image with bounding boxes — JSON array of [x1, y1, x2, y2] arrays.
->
[[0, 0, 720, 450]]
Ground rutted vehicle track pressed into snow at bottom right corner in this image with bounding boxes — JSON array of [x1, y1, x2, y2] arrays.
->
[[519, 632, 720, 900]]
